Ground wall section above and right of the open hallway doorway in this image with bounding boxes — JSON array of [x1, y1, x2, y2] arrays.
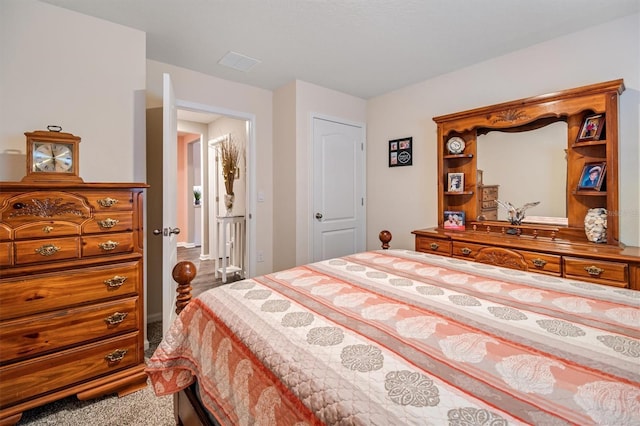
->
[[147, 60, 273, 275]]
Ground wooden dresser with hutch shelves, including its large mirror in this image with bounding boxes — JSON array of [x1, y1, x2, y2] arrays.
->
[[413, 80, 640, 290]]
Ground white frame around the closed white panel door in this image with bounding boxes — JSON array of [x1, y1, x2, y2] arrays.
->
[[307, 112, 367, 261]]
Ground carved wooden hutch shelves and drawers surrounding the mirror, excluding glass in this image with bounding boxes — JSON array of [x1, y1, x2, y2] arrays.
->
[[413, 79, 640, 290]]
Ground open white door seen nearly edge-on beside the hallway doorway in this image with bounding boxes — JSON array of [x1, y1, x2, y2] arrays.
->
[[162, 74, 180, 334]]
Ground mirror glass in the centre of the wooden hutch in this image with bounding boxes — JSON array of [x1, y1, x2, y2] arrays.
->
[[477, 121, 568, 225]]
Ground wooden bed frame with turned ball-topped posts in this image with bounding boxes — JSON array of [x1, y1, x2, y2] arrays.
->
[[172, 230, 392, 426]]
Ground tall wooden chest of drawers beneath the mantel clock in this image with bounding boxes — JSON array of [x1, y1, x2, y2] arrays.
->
[[0, 182, 146, 424]]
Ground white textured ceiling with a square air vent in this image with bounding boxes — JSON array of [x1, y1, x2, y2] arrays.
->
[[42, 0, 640, 99]]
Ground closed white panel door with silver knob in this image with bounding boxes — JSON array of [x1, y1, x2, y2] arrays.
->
[[312, 117, 365, 262]]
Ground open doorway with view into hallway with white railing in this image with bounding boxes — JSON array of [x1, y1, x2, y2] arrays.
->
[[177, 106, 253, 282]]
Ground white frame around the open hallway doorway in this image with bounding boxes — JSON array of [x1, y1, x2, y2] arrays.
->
[[176, 98, 257, 278]]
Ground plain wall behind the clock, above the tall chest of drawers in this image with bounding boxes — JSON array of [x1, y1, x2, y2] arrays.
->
[[0, 0, 146, 182]]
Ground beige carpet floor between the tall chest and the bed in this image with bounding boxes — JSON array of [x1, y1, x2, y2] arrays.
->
[[18, 322, 176, 426]]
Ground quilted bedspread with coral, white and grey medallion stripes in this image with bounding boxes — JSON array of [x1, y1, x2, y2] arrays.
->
[[147, 250, 640, 426]]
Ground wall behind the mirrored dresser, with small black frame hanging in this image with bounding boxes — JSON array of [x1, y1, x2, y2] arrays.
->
[[367, 15, 640, 249]]
